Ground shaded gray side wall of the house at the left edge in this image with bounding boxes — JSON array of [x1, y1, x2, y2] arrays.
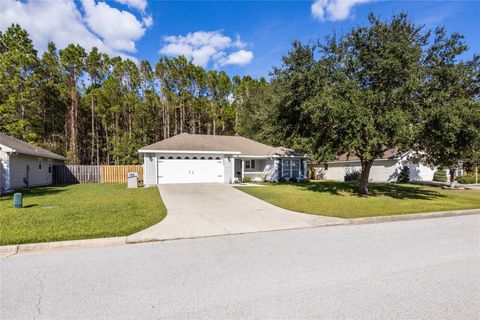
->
[[9, 154, 53, 189]]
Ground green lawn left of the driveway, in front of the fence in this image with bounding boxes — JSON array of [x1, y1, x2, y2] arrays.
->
[[0, 184, 167, 245]]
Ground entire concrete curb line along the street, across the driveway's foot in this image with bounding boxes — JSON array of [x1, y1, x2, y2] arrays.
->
[[0, 209, 480, 258]]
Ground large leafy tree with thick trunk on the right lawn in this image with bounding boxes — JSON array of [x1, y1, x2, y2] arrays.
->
[[273, 13, 479, 194]]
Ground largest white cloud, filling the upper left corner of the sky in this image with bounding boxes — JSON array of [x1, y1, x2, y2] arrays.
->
[[0, 0, 148, 59]]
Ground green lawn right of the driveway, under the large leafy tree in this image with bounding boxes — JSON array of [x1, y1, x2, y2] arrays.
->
[[237, 181, 480, 218]]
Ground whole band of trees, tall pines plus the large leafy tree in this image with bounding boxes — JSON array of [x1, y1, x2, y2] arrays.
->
[[0, 13, 480, 194]]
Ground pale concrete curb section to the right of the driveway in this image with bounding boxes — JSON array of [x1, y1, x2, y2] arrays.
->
[[348, 209, 480, 225]]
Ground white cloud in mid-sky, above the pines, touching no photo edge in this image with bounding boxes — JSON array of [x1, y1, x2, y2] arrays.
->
[[160, 31, 253, 67]]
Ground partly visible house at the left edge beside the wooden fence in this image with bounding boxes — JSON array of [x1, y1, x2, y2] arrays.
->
[[0, 133, 66, 193]]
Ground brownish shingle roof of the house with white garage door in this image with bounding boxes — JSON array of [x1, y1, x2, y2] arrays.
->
[[139, 133, 303, 156]]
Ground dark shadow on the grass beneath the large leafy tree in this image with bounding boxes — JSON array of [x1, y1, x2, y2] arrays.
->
[[295, 181, 445, 200]]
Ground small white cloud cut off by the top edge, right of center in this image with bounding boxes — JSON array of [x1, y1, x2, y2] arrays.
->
[[311, 0, 371, 21]]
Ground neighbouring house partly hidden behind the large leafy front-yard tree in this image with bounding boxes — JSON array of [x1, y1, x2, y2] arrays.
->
[[321, 148, 435, 182]]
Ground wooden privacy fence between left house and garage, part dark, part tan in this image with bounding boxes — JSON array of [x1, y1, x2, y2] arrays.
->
[[53, 165, 143, 184]]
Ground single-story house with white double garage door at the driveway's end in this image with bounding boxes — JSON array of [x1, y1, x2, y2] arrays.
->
[[138, 133, 307, 184]]
